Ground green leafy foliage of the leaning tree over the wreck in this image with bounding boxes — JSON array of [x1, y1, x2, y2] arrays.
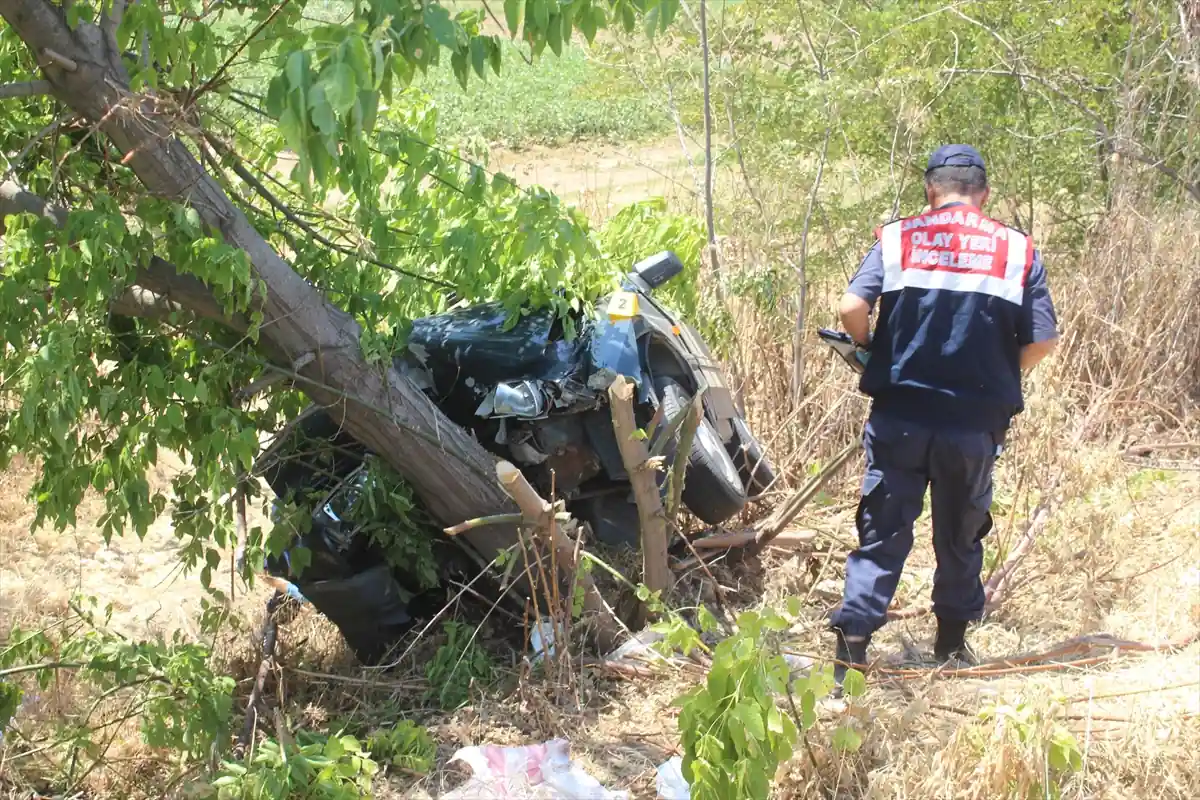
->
[[0, 0, 678, 582]]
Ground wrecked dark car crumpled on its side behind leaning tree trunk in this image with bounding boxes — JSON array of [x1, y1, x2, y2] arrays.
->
[[256, 252, 775, 662]]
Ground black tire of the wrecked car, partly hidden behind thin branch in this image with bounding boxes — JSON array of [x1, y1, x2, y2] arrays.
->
[[656, 378, 746, 525]]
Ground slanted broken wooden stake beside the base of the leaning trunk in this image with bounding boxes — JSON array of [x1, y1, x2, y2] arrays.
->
[[496, 461, 620, 652]]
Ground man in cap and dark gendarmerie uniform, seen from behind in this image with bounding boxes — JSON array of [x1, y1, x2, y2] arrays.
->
[[832, 144, 1058, 685]]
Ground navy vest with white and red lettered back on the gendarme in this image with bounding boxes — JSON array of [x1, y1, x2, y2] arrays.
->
[[862, 204, 1033, 431]]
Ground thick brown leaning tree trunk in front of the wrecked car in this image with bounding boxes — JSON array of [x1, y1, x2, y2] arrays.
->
[[0, 0, 517, 558]]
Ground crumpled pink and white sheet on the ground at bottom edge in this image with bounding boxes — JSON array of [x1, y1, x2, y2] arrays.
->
[[442, 739, 629, 800]]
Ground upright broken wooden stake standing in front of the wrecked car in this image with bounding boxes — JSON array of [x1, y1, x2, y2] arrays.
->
[[608, 377, 674, 591]]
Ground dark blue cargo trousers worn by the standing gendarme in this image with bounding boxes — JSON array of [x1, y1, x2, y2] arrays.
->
[[832, 411, 1003, 636]]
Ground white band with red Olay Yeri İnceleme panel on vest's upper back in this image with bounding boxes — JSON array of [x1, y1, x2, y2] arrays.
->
[[880, 213, 1033, 305]]
